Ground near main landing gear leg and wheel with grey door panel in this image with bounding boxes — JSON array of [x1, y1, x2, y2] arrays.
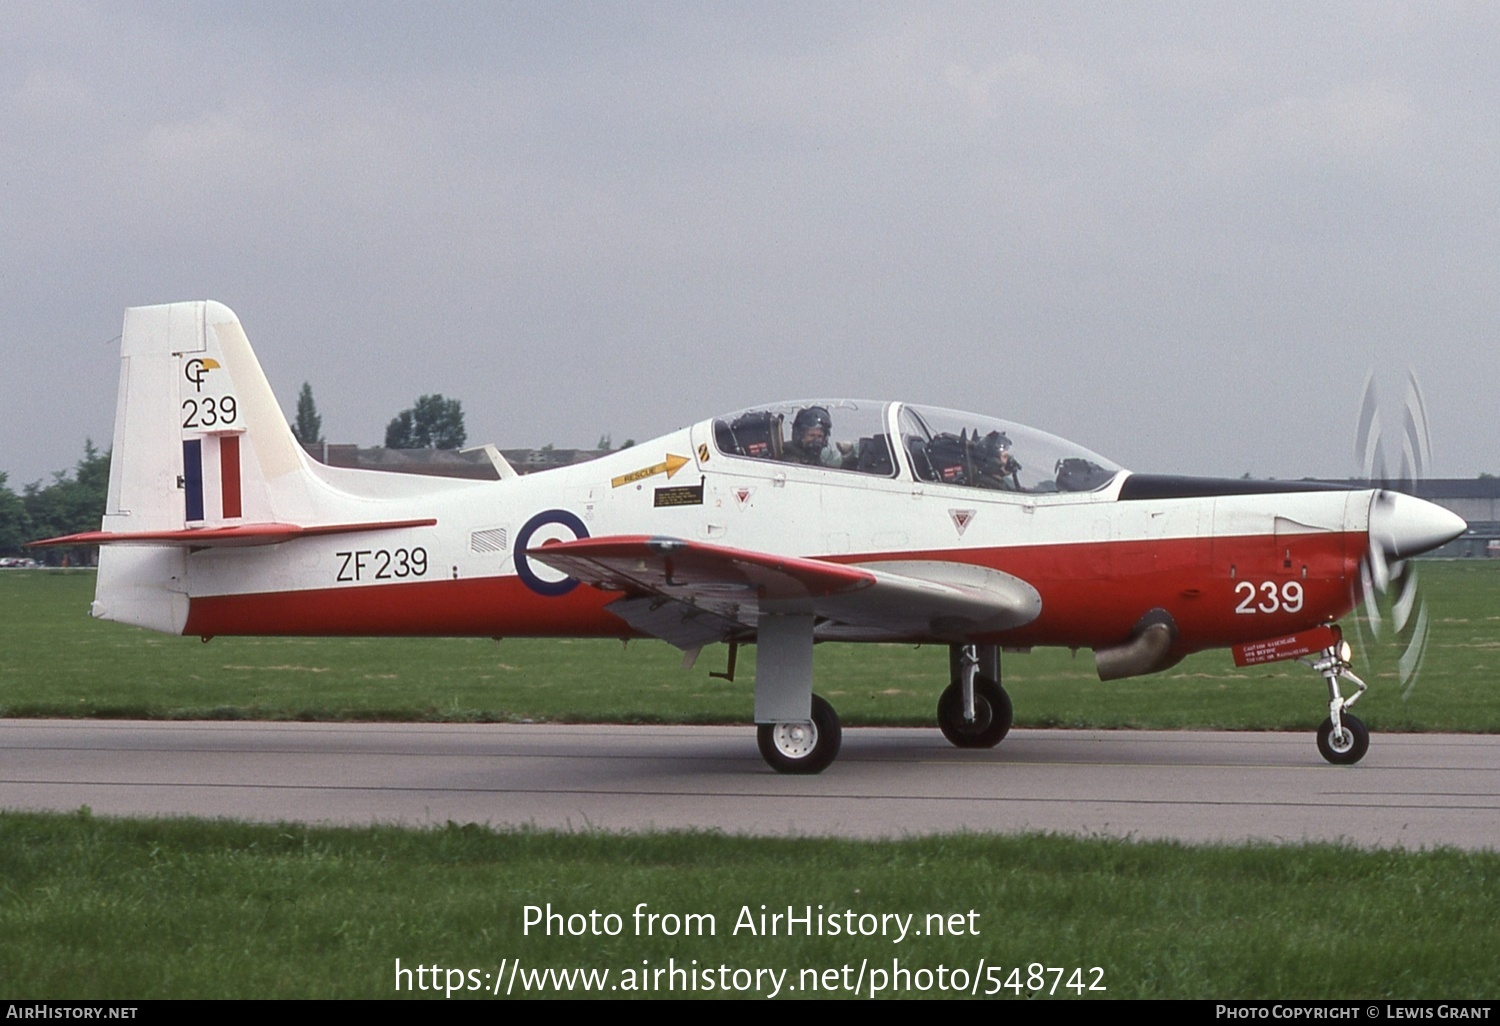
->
[[755, 614, 843, 774]]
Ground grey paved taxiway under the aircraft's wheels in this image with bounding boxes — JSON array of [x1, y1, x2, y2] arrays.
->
[[0, 720, 1500, 849]]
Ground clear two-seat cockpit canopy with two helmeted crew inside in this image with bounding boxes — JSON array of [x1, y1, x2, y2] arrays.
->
[[714, 399, 1122, 494]]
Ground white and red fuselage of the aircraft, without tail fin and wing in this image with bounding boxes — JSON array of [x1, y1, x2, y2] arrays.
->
[[170, 404, 1398, 651]]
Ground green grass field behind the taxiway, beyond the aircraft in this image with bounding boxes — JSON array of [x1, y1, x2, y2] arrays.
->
[[0, 561, 1500, 732]]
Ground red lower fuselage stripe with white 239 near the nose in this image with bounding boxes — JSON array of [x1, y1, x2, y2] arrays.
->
[[183, 533, 1365, 651]]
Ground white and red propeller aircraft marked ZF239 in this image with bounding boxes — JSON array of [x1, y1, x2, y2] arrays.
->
[[42, 303, 1466, 773]]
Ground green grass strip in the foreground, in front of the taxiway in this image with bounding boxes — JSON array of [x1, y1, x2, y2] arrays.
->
[[0, 813, 1500, 999]]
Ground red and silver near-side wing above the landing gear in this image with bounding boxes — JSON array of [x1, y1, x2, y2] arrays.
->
[[527, 536, 1041, 648]]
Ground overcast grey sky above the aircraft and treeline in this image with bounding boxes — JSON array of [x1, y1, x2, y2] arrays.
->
[[0, 2, 1500, 488]]
